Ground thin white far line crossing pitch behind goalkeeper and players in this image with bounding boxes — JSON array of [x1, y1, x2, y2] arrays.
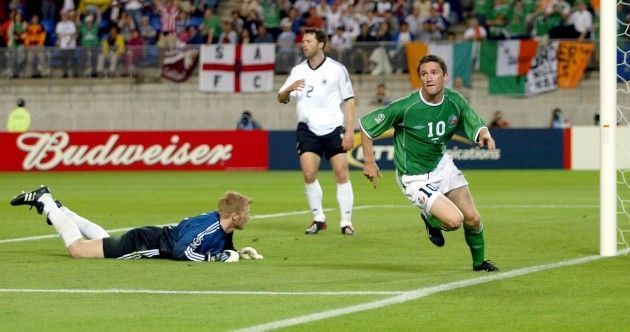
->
[[0, 204, 599, 244]]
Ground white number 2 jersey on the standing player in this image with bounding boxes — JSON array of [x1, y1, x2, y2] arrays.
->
[[278, 57, 354, 136]]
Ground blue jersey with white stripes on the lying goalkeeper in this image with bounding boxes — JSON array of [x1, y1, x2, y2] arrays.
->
[[168, 211, 234, 261]]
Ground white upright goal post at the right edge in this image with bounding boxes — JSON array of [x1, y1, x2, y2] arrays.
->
[[599, 0, 618, 256]]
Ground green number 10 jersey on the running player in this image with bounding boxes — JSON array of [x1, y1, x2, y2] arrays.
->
[[360, 88, 485, 175]]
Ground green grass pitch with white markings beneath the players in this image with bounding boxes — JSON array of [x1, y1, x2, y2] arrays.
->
[[0, 171, 630, 331]]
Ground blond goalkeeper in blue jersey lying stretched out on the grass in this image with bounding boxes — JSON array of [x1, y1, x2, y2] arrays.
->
[[11, 187, 263, 262]]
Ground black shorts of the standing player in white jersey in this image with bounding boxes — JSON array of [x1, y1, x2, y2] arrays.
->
[[296, 122, 345, 160]]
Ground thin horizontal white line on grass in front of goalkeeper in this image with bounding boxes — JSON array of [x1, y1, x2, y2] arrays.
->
[[0, 288, 404, 296]]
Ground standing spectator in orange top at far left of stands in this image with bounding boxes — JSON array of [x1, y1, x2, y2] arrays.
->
[[24, 15, 48, 77]]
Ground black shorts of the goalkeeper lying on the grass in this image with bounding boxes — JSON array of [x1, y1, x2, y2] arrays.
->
[[103, 226, 172, 259]]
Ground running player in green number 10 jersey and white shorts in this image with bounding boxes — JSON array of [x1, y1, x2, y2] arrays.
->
[[360, 55, 498, 271]]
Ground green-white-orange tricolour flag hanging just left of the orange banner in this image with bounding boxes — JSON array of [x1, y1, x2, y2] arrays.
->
[[479, 40, 538, 77]]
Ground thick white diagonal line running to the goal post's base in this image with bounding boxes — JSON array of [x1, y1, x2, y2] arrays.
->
[[235, 249, 630, 332]]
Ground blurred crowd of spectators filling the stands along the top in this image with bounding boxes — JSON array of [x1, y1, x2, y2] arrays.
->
[[0, 0, 604, 77]]
